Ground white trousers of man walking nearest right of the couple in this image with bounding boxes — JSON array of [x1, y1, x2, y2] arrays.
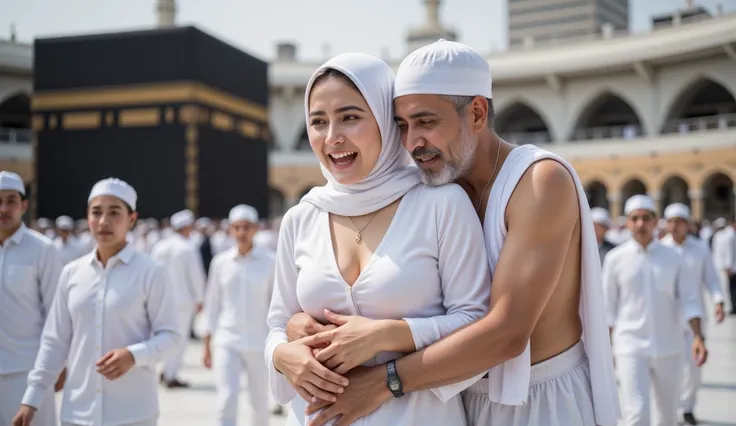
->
[[616, 355, 682, 426]]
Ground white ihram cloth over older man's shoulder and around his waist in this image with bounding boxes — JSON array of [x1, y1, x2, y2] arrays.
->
[[466, 145, 620, 426]]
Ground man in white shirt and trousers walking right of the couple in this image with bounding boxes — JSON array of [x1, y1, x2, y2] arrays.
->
[[603, 195, 707, 426]]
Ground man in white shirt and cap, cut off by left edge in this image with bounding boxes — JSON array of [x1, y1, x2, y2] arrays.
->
[[0, 171, 62, 426]]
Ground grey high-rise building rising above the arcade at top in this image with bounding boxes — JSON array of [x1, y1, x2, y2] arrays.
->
[[508, 0, 629, 46]]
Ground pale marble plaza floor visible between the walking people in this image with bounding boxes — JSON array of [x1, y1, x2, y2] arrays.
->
[[57, 316, 736, 426]]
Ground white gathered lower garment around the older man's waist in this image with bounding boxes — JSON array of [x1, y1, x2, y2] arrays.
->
[[463, 341, 596, 426]]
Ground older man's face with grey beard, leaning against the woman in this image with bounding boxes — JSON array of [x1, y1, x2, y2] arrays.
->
[[394, 95, 477, 186]]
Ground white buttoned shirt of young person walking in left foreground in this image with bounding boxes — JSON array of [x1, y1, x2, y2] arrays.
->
[[23, 244, 183, 426]]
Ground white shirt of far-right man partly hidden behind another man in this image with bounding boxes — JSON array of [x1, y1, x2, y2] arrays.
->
[[660, 234, 725, 327]]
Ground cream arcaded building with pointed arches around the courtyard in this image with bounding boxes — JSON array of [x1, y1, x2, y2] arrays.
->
[[0, 2, 736, 219]]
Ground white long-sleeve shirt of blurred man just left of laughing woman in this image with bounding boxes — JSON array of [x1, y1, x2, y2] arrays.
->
[[203, 247, 276, 352]]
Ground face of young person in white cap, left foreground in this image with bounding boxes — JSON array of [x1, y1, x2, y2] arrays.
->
[[87, 195, 138, 247]]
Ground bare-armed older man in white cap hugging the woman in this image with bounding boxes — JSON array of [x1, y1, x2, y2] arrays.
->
[[293, 40, 619, 426]]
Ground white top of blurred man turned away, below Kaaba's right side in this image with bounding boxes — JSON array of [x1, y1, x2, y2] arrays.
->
[[151, 233, 207, 310]]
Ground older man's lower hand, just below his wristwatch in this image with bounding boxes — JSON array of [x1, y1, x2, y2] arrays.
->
[[306, 365, 392, 426]]
